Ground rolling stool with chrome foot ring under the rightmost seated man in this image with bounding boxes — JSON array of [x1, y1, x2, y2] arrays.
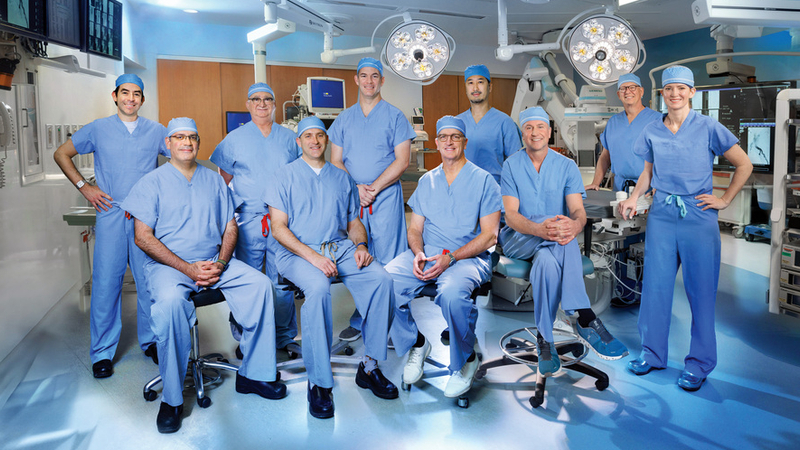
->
[[475, 250, 608, 408]]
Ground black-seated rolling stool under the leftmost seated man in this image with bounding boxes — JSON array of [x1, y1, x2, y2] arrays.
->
[[143, 289, 239, 408]]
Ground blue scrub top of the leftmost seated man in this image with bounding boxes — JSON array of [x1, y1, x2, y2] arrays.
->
[[121, 164, 233, 264]]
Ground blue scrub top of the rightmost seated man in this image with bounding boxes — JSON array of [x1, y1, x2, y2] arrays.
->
[[500, 149, 586, 223]]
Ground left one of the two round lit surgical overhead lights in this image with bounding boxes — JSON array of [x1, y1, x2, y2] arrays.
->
[[381, 17, 455, 84]]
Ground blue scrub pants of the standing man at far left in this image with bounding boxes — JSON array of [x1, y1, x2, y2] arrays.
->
[[89, 206, 156, 364]]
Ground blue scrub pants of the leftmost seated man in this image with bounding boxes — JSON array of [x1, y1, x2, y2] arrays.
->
[[147, 259, 276, 406]]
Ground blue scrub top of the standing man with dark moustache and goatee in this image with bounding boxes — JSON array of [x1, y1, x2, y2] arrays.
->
[[458, 108, 522, 184]]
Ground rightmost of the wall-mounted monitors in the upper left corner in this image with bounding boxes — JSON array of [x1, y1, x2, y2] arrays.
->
[[82, 0, 122, 61]]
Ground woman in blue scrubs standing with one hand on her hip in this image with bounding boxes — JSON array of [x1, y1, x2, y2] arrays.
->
[[618, 66, 753, 391]]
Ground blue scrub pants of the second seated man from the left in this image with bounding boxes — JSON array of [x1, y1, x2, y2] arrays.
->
[[278, 239, 394, 388]]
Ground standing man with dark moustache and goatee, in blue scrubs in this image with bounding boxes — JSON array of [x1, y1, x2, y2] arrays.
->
[[457, 65, 522, 184]]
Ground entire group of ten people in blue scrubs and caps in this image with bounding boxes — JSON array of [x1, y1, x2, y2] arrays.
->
[[62, 58, 752, 433]]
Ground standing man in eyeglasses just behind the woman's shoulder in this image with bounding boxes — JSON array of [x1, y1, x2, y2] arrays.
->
[[586, 73, 661, 191]]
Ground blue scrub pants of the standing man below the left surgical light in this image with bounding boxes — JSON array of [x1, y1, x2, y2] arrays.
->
[[350, 182, 408, 330]]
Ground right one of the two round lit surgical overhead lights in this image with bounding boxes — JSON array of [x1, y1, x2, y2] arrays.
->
[[564, 14, 644, 84]]
